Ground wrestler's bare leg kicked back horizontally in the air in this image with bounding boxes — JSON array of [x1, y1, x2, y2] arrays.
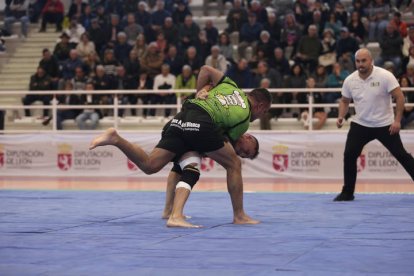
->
[[89, 128, 175, 174]]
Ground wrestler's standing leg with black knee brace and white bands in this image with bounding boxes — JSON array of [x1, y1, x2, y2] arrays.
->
[[167, 152, 201, 228]]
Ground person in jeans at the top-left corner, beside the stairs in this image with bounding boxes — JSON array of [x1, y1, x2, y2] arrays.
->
[[4, 0, 29, 38]]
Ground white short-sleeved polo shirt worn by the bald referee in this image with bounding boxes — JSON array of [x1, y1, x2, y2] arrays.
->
[[342, 66, 399, 127]]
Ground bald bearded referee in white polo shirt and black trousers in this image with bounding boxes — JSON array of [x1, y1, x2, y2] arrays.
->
[[334, 48, 414, 201]]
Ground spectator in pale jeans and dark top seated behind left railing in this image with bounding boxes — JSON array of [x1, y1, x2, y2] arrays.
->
[[75, 82, 102, 130]]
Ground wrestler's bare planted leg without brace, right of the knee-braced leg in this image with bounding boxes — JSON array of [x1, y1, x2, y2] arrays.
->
[[206, 143, 260, 224]]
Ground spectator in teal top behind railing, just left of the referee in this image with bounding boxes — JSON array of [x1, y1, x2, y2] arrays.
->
[[323, 63, 349, 117]]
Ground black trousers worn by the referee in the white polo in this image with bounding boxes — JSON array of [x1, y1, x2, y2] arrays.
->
[[342, 122, 414, 194]]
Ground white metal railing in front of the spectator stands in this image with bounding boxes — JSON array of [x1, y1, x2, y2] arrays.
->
[[0, 88, 414, 133]]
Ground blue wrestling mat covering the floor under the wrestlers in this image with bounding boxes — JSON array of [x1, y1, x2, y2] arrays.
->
[[0, 190, 414, 276]]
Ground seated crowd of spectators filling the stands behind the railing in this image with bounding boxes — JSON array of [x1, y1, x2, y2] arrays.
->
[[3, 0, 414, 129]]
